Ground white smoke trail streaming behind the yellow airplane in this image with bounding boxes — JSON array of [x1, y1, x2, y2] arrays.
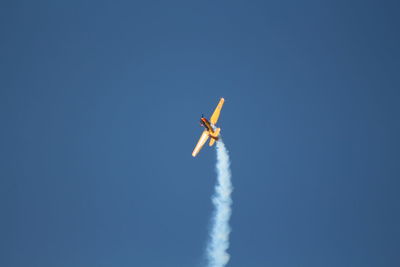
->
[[207, 139, 233, 267]]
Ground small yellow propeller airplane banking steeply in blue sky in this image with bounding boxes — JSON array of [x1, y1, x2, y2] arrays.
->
[[192, 98, 225, 157]]
